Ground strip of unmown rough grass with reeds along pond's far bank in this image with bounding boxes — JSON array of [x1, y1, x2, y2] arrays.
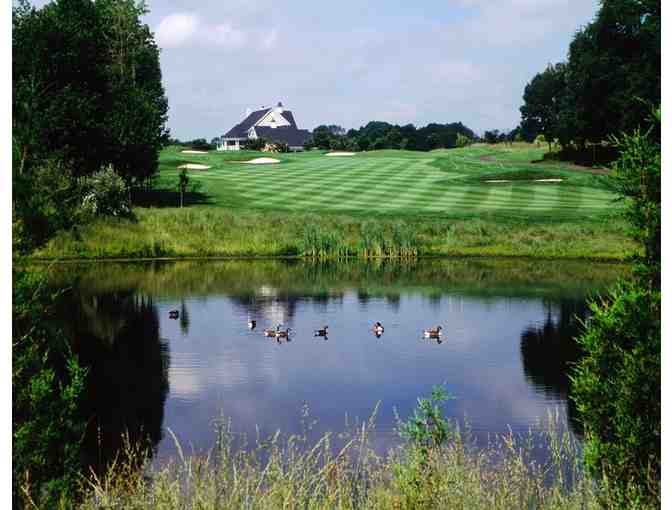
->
[[32, 207, 635, 260]]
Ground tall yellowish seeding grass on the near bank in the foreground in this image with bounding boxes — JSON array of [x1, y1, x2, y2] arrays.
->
[[65, 411, 604, 510]]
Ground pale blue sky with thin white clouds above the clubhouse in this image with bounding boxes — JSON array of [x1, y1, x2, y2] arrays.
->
[[27, 0, 598, 140]]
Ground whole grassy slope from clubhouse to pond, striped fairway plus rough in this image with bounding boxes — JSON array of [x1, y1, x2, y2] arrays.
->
[[30, 145, 633, 259]]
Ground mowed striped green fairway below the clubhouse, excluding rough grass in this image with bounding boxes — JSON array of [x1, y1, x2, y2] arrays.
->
[[158, 146, 615, 221]]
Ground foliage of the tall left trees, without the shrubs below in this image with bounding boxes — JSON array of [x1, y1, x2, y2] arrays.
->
[[12, 0, 168, 183]]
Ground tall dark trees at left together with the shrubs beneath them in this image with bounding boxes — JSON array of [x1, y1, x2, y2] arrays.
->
[[12, 0, 168, 248]]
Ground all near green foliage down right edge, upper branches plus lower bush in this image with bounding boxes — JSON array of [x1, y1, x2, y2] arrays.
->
[[572, 109, 661, 508]]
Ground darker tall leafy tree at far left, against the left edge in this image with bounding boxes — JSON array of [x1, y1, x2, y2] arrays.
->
[[12, 0, 108, 176]]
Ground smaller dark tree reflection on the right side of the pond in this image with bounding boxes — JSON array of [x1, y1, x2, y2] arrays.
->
[[520, 301, 589, 434]]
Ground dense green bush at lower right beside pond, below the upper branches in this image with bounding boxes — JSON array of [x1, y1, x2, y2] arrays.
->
[[572, 282, 661, 508]]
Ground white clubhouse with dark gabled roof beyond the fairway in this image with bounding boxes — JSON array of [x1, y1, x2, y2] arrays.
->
[[217, 103, 310, 151]]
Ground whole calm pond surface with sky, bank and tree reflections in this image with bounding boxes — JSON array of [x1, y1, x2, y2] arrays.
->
[[43, 259, 625, 472]]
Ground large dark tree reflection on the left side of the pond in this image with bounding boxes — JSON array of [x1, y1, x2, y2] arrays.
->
[[61, 291, 170, 478]]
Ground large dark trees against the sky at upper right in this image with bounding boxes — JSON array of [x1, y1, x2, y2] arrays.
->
[[519, 0, 661, 159]]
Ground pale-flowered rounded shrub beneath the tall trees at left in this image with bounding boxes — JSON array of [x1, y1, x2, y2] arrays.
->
[[81, 165, 131, 217]]
